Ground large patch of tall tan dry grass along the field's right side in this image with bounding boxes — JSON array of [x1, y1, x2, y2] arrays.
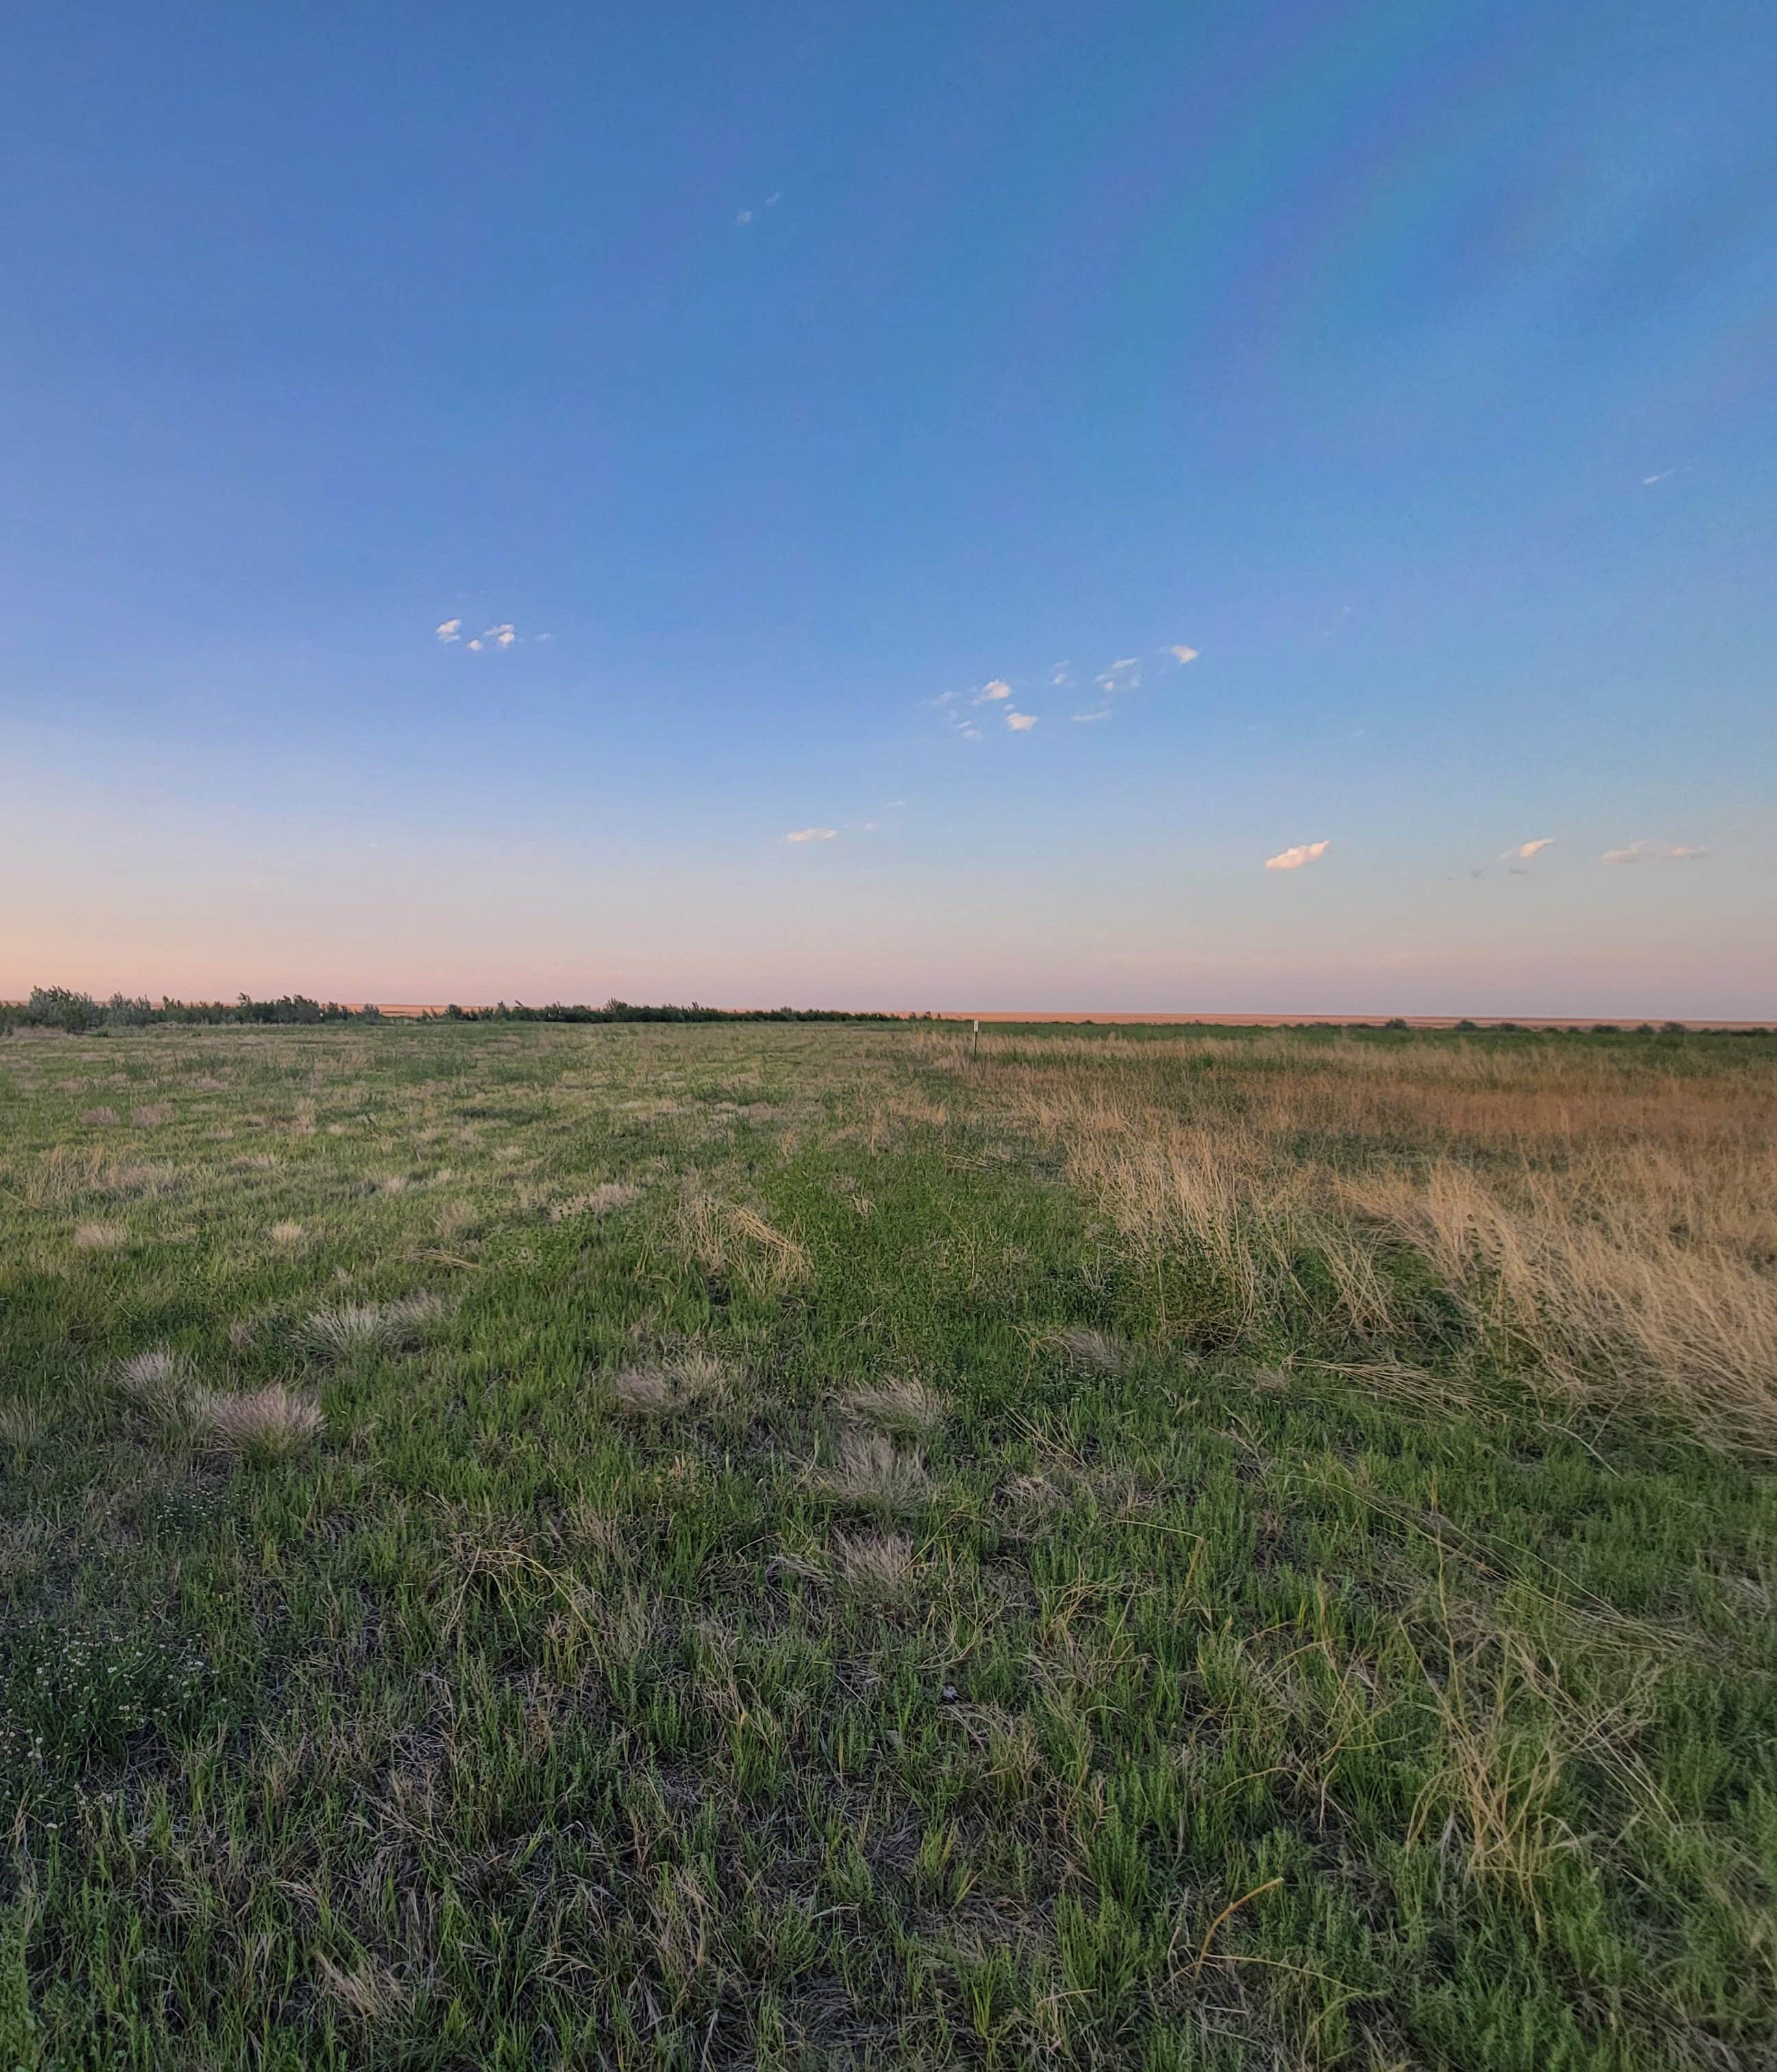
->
[[948, 1034, 1777, 1451]]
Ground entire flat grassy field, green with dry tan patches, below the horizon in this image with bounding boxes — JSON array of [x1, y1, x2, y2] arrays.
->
[[0, 1024, 1777, 2072]]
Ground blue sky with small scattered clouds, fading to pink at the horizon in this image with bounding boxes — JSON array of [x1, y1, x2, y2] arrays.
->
[[0, 0, 1777, 1020]]
